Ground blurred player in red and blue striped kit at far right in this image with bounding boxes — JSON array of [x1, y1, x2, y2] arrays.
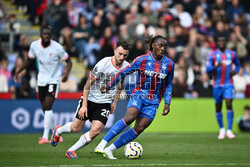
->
[[207, 34, 241, 139]]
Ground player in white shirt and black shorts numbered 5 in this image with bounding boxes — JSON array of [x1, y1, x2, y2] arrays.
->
[[14, 26, 72, 144]]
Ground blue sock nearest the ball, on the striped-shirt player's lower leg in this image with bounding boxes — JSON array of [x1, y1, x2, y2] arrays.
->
[[113, 128, 138, 149]]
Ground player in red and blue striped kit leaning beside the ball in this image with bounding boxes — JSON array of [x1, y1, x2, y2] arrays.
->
[[94, 35, 174, 159]]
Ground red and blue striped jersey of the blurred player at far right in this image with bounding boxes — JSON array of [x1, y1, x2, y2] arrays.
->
[[207, 49, 241, 86]]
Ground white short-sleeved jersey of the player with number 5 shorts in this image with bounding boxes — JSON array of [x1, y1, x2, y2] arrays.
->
[[29, 39, 69, 86]]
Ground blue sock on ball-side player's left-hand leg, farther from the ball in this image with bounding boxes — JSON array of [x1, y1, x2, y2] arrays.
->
[[103, 119, 127, 142]]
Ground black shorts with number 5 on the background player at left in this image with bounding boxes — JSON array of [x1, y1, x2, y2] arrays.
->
[[38, 84, 58, 101]]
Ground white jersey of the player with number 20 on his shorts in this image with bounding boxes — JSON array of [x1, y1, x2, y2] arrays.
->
[[88, 57, 129, 103]]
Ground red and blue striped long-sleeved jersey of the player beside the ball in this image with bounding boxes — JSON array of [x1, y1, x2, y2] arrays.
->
[[108, 53, 174, 104]]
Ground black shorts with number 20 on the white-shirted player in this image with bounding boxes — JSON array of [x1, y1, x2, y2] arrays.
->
[[75, 97, 111, 125]]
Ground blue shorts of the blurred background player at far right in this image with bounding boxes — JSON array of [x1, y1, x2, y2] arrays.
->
[[213, 85, 234, 104]]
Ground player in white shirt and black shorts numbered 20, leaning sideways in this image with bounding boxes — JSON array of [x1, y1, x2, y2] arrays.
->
[[51, 40, 129, 158]]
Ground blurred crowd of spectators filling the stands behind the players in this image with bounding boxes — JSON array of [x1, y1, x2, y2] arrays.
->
[[0, 0, 250, 98]]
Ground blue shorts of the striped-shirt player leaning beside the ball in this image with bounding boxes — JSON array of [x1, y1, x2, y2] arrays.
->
[[127, 98, 159, 122]]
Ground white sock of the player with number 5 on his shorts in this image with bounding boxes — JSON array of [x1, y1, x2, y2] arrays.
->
[[43, 110, 53, 139]]
